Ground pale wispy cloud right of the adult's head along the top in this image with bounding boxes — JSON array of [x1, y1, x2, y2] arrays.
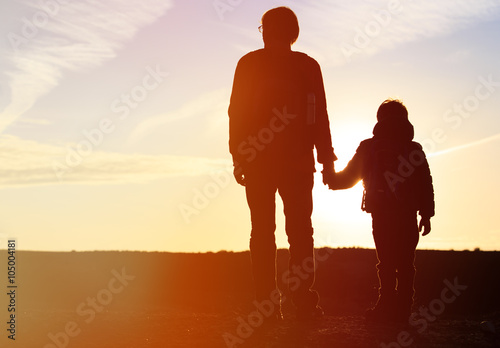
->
[[290, 0, 500, 66]]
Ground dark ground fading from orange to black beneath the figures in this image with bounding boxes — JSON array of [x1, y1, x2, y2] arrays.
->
[[0, 249, 500, 348]]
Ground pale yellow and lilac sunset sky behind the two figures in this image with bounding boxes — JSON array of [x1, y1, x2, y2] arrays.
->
[[0, 0, 500, 252]]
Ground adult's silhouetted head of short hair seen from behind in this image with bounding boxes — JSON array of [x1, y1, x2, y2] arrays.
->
[[261, 6, 299, 45]]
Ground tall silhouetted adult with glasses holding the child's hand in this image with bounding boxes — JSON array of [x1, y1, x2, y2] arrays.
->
[[229, 7, 336, 319]]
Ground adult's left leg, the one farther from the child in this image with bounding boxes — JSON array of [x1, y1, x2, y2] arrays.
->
[[245, 174, 277, 301]]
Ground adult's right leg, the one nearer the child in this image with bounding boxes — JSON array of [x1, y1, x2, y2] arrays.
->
[[278, 171, 319, 315]]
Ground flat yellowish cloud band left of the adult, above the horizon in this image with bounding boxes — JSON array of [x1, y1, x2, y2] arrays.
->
[[0, 135, 231, 187]]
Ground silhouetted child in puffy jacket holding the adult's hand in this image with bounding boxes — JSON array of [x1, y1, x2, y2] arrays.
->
[[327, 99, 434, 322]]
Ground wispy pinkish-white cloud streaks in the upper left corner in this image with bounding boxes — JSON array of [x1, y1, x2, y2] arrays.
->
[[0, 0, 172, 132]]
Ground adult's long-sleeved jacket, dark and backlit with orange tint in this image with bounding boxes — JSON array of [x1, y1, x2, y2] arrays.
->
[[228, 49, 336, 173]]
